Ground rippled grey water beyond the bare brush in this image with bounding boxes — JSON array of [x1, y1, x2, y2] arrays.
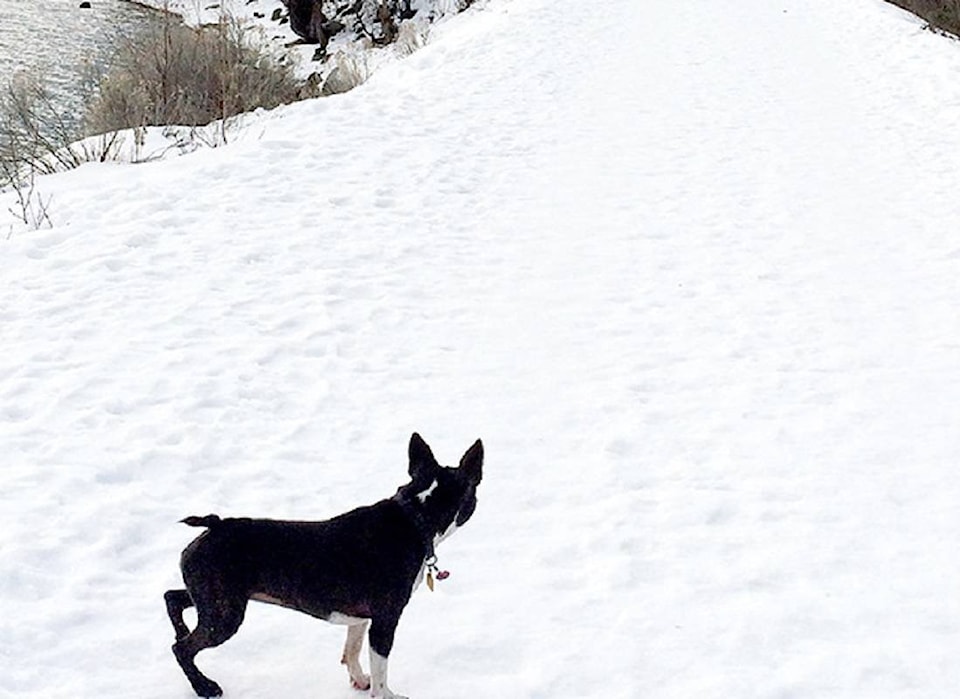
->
[[0, 0, 158, 137]]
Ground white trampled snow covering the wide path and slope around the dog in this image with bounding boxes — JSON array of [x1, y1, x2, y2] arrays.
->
[[0, 0, 960, 699]]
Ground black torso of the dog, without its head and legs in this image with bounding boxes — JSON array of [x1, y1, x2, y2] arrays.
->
[[180, 500, 423, 619]]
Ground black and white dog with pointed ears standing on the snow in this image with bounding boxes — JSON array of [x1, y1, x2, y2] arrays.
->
[[164, 433, 483, 699]]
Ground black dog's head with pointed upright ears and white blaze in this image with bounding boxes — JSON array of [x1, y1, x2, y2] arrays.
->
[[398, 432, 483, 540]]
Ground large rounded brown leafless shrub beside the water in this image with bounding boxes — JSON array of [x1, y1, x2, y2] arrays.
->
[[87, 10, 304, 133]]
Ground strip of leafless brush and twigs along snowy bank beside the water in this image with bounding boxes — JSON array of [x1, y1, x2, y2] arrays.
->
[[0, 13, 319, 198]]
